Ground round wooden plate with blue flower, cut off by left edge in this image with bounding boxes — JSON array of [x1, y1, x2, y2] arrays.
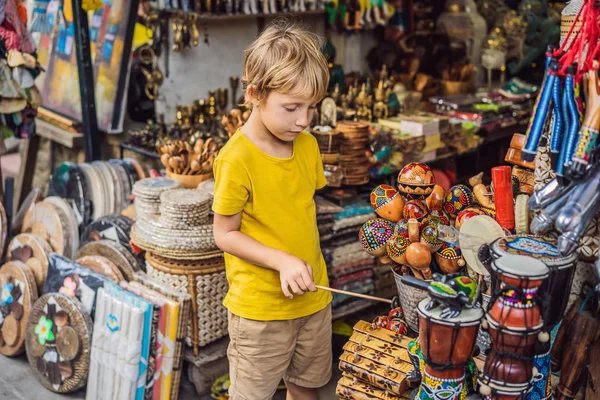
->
[[0, 261, 38, 357]]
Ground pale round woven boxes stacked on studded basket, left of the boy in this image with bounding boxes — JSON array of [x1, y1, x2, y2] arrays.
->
[[131, 178, 228, 355]]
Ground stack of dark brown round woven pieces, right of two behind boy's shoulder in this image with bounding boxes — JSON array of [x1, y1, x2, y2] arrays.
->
[[336, 121, 369, 185]]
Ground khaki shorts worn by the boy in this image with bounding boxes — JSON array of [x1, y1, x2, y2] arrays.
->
[[227, 304, 332, 400]]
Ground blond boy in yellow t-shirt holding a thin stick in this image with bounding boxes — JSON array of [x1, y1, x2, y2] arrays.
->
[[213, 21, 332, 400]]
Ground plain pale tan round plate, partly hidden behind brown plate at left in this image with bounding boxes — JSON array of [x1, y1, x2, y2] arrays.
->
[[22, 202, 71, 255]]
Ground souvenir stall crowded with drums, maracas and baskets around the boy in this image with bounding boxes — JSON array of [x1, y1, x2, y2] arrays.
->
[[0, 0, 600, 400]]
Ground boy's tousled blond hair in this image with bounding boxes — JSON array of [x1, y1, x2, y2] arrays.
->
[[242, 18, 329, 101]]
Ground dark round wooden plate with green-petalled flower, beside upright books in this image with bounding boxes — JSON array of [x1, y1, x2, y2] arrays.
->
[[25, 293, 92, 393]]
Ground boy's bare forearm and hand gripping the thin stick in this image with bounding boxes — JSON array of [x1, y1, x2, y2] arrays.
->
[[213, 212, 317, 299]]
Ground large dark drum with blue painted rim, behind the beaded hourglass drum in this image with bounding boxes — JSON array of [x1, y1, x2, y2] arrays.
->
[[490, 235, 577, 400]]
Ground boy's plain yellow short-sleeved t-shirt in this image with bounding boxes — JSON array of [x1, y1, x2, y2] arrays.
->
[[213, 130, 331, 321]]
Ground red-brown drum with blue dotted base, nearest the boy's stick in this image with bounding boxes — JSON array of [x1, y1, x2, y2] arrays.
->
[[416, 298, 483, 400]]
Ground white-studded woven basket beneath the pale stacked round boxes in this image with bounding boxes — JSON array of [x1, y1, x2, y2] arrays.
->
[[146, 252, 229, 354]]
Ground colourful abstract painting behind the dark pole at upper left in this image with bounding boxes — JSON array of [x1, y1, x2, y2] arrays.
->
[[37, 0, 139, 133]]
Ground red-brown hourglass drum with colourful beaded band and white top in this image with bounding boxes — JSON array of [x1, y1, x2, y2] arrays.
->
[[478, 255, 549, 400]]
